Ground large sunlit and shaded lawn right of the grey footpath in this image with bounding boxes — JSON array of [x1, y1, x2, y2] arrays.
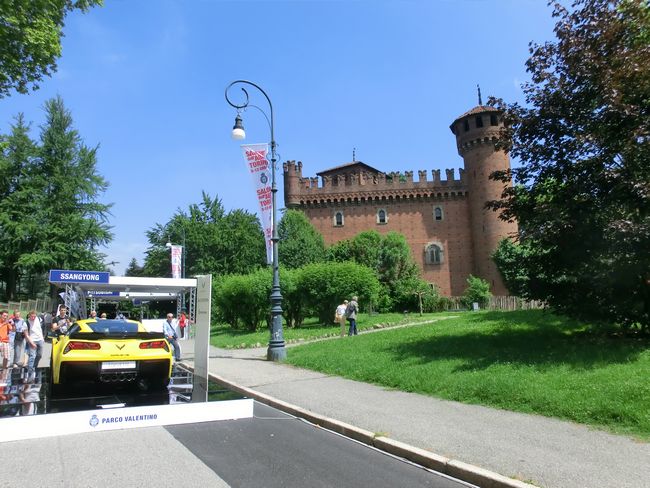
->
[[288, 311, 650, 440]]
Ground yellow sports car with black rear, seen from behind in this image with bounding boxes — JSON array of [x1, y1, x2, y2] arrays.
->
[[50, 319, 172, 386]]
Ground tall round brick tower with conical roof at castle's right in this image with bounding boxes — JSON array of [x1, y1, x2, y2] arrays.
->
[[449, 93, 517, 295]]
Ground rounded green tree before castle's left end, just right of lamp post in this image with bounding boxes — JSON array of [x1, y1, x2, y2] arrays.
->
[[278, 209, 325, 269]]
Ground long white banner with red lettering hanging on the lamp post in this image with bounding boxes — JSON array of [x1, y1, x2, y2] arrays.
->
[[242, 144, 273, 264]]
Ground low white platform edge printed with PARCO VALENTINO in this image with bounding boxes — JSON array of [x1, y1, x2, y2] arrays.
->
[[0, 398, 253, 442]]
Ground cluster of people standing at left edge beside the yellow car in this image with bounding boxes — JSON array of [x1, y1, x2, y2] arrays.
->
[[0, 310, 45, 373]]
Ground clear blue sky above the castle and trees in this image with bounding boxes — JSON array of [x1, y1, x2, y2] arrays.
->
[[0, 0, 553, 274]]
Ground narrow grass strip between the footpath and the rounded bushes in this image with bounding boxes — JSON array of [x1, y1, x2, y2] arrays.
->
[[210, 313, 454, 349]]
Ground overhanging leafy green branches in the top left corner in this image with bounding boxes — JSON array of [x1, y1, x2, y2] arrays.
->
[[0, 0, 103, 98]]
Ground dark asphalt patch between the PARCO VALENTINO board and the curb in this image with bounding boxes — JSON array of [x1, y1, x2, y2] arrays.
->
[[166, 402, 473, 488]]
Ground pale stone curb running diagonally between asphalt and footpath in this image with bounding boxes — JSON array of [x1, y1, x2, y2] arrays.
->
[[205, 368, 538, 488]]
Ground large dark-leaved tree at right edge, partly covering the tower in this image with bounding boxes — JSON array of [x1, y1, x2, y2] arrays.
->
[[491, 0, 650, 327]]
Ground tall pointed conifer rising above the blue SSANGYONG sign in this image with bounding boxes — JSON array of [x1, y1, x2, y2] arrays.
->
[[19, 97, 112, 278]]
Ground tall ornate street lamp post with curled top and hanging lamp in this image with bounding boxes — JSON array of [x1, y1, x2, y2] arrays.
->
[[225, 80, 287, 361]]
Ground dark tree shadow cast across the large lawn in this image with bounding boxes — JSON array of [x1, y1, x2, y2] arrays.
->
[[386, 312, 650, 371]]
